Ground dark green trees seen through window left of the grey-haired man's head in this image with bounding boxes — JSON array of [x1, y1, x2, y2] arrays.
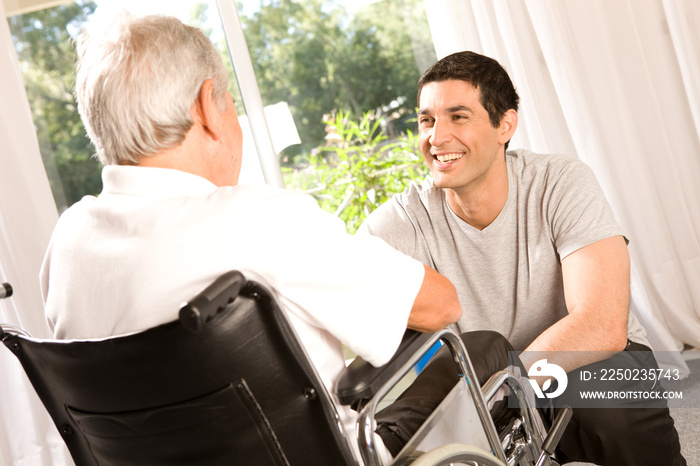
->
[[8, 1, 102, 209]]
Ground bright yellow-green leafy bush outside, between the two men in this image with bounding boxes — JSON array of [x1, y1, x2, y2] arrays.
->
[[283, 111, 428, 233]]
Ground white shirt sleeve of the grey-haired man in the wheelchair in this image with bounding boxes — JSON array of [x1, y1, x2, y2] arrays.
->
[[264, 190, 425, 366]]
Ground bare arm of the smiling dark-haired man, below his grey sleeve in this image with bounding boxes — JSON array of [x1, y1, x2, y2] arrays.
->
[[521, 236, 630, 372]]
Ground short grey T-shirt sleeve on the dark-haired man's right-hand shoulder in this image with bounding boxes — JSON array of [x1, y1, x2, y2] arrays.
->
[[546, 160, 623, 260]]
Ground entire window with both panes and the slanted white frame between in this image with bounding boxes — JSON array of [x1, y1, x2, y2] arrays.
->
[[8, 0, 435, 231]]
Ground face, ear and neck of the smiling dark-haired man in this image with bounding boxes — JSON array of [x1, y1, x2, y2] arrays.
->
[[418, 80, 518, 230]]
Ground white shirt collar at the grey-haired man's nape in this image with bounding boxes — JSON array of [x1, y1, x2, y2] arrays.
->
[[102, 165, 217, 198]]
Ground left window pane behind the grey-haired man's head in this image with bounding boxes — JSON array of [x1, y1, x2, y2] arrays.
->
[[8, 0, 252, 212]]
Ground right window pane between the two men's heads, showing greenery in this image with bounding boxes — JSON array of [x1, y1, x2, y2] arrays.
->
[[240, 0, 436, 232]]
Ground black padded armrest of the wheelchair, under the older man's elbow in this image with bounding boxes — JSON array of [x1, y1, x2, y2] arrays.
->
[[335, 330, 432, 411]]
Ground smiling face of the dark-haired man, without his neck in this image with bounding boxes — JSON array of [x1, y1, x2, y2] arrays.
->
[[418, 80, 512, 193]]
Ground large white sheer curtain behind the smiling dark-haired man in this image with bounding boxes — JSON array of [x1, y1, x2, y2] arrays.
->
[[425, 0, 700, 371]]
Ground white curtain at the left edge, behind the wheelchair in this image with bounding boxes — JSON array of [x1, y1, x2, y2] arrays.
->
[[0, 2, 72, 466]]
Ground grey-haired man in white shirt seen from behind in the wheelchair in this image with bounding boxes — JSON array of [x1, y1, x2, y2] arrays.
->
[[41, 15, 468, 460]]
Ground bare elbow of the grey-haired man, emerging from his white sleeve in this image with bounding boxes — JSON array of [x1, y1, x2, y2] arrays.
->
[[408, 265, 462, 332]]
